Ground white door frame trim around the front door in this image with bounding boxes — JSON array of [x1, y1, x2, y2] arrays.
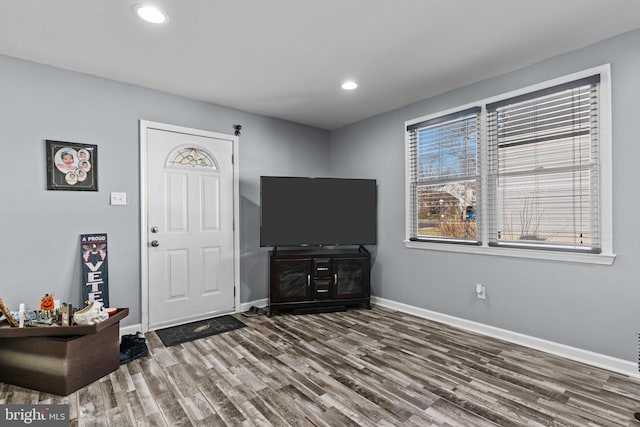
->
[[140, 120, 240, 332]]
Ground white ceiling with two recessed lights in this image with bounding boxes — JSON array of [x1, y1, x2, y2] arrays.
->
[[0, 0, 640, 130]]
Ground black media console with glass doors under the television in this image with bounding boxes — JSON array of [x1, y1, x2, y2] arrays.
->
[[269, 249, 371, 316]]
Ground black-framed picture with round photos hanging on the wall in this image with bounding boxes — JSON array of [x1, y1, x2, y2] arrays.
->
[[45, 139, 98, 191]]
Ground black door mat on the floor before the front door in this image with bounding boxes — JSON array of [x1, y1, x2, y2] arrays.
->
[[155, 315, 247, 347]]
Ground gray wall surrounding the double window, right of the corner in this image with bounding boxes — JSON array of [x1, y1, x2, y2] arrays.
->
[[331, 31, 640, 361]]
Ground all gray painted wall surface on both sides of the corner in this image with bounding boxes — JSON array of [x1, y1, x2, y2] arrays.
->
[[0, 32, 640, 360]]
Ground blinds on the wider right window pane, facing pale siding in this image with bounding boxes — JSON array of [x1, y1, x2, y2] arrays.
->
[[487, 75, 600, 252]]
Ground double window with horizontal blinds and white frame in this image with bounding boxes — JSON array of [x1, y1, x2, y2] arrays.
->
[[405, 64, 615, 264]]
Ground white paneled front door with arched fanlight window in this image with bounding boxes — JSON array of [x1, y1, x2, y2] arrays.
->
[[143, 123, 236, 330]]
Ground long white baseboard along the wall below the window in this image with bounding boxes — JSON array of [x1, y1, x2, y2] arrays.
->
[[371, 297, 640, 378]]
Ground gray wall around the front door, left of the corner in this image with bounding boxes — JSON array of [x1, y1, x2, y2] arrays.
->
[[0, 56, 329, 325]]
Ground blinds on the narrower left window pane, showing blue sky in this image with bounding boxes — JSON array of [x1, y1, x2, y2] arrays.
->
[[407, 108, 480, 244]]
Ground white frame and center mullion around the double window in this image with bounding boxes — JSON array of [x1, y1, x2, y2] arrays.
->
[[404, 64, 615, 265]]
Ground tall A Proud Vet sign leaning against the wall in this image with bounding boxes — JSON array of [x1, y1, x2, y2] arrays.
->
[[80, 233, 109, 307]]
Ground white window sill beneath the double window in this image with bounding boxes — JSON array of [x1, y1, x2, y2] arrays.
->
[[404, 240, 616, 265]]
